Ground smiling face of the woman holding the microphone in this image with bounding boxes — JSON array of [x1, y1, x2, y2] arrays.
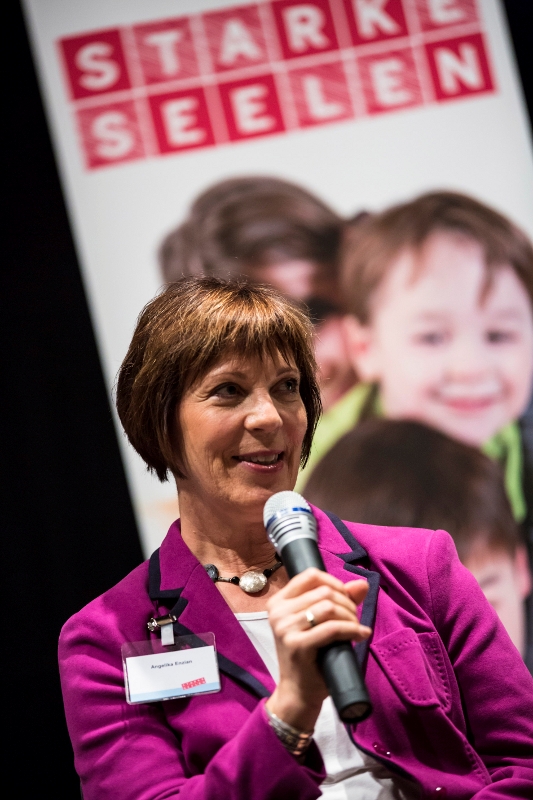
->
[[177, 355, 307, 519]]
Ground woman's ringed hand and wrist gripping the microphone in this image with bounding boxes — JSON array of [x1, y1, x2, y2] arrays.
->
[[267, 569, 372, 731]]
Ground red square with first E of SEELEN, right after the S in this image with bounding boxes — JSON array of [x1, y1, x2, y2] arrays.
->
[[150, 89, 215, 153]]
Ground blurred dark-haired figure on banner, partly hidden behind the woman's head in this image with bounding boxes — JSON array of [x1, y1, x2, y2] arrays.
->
[[159, 176, 355, 409]]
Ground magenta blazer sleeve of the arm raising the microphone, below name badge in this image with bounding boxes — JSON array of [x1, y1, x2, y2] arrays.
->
[[59, 606, 325, 800]]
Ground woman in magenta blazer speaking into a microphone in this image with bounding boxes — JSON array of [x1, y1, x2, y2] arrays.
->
[[60, 279, 533, 800]]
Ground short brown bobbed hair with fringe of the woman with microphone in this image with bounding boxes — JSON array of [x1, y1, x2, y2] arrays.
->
[[116, 278, 321, 481]]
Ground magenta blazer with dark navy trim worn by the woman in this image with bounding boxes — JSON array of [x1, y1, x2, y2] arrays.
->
[[59, 509, 533, 800]]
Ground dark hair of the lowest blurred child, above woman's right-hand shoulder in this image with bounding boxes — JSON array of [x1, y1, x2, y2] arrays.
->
[[305, 419, 521, 560]]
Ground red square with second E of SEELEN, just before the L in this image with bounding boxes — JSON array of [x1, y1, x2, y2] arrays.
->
[[218, 75, 285, 140]]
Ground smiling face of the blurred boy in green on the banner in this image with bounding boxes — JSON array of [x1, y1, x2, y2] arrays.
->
[[346, 232, 533, 446]]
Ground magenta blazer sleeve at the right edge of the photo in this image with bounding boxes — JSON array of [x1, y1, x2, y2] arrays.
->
[[427, 531, 533, 800]]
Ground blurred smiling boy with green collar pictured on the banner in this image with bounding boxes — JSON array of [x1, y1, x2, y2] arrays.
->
[[298, 192, 533, 536]]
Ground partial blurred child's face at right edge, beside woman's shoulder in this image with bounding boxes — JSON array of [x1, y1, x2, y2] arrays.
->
[[463, 540, 531, 657]]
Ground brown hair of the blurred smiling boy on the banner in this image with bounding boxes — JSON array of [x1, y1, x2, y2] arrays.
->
[[341, 192, 533, 325]]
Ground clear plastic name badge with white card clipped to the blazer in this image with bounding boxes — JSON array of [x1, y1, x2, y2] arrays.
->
[[122, 633, 220, 704]]
